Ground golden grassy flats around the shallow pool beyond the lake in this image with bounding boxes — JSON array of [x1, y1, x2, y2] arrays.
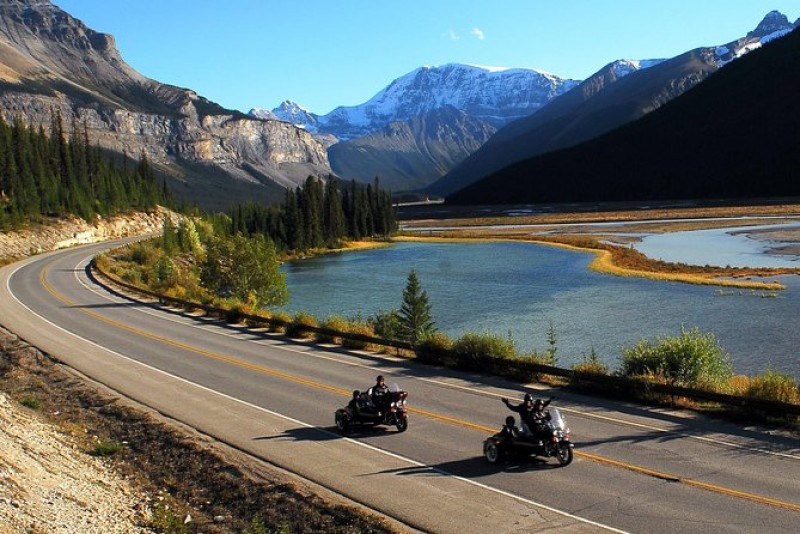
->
[[401, 204, 800, 291]]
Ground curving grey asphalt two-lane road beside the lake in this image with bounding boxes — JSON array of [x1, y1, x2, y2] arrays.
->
[[0, 244, 800, 533]]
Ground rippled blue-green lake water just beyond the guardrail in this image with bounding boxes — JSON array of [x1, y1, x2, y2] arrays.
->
[[283, 242, 800, 378]]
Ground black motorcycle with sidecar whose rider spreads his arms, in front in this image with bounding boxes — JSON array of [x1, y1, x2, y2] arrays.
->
[[483, 408, 574, 466]]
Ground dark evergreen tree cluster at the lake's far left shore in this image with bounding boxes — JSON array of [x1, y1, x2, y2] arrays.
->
[[227, 176, 397, 252]]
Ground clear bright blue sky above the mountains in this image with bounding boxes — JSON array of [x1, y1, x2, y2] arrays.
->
[[52, 0, 800, 115]]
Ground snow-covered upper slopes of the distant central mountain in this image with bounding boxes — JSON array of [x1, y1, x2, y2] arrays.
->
[[251, 64, 580, 139]]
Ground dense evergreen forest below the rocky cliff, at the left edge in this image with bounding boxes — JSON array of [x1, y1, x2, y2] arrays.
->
[[0, 113, 172, 229]]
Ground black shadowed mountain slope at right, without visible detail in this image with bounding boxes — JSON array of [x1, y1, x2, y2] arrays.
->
[[447, 30, 800, 204]]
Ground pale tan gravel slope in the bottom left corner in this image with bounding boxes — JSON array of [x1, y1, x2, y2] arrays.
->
[[0, 393, 151, 534]]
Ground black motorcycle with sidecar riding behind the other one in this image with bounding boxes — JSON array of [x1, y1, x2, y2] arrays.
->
[[334, 384, 408, 434]]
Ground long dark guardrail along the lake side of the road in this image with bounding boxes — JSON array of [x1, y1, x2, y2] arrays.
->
[[89, 259, 800, 417]]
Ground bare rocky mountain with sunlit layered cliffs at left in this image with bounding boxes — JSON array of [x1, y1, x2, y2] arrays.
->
[[0, 0, 331, 209]]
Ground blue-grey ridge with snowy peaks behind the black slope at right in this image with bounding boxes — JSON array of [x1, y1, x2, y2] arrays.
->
[[428, 11, 793, 196]]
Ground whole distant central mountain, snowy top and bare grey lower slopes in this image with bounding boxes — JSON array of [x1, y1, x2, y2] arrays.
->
[[250, 64, 578, 191]]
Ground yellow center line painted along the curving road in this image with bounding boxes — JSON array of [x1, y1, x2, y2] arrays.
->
[[39, 265, 800, 512]]
